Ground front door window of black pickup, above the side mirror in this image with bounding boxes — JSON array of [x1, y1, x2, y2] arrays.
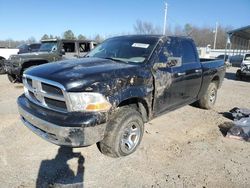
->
[[158, 38, 181, 63]]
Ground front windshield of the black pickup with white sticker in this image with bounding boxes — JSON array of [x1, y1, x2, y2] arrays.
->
[[87, 37, 158, 63]]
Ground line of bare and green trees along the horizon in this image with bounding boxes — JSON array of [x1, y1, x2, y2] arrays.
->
[[0, 20, 232, 49]]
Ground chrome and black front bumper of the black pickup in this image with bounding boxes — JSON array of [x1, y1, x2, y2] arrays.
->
[[17, 95, 106, 147]]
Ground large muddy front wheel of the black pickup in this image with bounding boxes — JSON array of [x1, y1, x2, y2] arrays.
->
[[98, 107, 144, 157]]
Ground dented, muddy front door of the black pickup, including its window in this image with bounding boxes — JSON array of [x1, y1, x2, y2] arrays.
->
[[153, 37, 186, 115]]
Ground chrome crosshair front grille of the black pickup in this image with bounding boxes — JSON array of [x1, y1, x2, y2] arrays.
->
[[23, 75, 67, 112]]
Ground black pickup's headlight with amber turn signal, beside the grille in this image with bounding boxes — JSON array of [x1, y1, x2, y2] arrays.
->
[[67, 92, 111, 112]]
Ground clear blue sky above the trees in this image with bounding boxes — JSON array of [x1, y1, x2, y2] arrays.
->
[[0, 0, 250, 40]]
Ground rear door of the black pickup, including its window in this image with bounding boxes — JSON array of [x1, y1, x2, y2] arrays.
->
[[181, 39, 202, 103]]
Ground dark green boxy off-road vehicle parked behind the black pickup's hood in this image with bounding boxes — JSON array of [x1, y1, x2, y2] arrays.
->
[[4, 39, 97, 83]]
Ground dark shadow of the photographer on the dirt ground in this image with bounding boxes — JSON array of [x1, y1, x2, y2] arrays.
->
[[36, 147, 85, 188]]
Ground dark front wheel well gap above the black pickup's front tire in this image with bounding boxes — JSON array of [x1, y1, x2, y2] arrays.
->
[[118, 98, 149, 122]]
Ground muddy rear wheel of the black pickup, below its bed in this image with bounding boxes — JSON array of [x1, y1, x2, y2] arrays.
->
[[199, 82, 218, 110]]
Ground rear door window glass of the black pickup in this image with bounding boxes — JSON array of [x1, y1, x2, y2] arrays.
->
[[181, 40, 196, 64]]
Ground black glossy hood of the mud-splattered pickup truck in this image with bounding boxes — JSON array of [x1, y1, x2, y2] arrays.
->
[[25, 58, 148, 91]]
